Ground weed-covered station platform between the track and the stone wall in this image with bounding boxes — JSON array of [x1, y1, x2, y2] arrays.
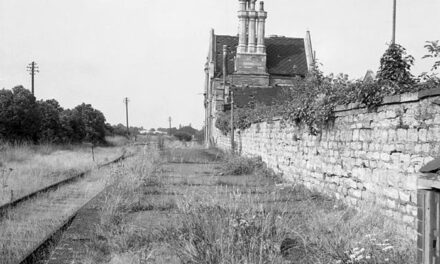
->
[[84, 142, 415, 264]]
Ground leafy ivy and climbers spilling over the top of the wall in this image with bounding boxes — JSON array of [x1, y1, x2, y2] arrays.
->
[[216, 42, 440, 134]]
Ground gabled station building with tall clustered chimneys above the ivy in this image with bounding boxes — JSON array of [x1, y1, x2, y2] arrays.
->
[[205, 0, 314, 145]]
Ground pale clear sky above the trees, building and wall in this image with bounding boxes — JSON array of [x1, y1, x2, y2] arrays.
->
[[0, 0, 440, 128]]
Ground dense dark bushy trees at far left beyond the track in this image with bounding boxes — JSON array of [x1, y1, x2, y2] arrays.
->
[[0, 86, 107, 144]]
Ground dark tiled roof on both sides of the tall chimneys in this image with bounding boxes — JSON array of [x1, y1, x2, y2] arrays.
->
[[215, 35, 307, 77]]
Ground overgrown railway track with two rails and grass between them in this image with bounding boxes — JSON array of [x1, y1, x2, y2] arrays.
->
[[0, 148, 133, 264]]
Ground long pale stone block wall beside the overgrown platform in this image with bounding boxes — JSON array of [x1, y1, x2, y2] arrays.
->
[[215, 89, 440, 229]]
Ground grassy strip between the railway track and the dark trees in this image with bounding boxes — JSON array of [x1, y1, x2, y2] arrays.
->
[[0, 137, 130, 205]]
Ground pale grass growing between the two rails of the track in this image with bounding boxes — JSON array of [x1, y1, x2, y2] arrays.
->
[[0, 159, 118, 264]]
